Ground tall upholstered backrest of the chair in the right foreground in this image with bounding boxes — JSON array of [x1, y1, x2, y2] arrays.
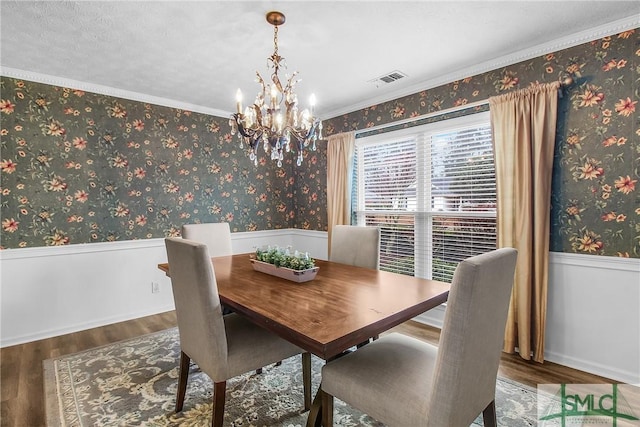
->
[[428, 248, 517, 426]]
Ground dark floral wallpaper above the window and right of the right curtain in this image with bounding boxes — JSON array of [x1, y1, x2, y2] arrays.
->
[[324, 29, 640, 258]]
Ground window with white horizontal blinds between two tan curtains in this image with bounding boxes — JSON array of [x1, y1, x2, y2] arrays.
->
[[353, 113, 496, 282]]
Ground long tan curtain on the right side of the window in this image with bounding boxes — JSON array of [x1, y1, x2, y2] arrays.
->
[[489, 82, 560, 362]]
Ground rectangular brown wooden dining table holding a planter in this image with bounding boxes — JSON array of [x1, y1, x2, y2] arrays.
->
[[158, 254, 450, 425]]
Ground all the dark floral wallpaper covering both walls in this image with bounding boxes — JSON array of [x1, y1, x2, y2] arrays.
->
[[0, 29, 640, 258]]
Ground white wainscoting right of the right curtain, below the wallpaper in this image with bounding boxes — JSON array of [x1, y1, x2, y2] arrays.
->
[[545, 252, 640, 384]]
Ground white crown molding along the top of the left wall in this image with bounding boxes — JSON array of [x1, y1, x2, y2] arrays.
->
[[0, 67, 231, 118]]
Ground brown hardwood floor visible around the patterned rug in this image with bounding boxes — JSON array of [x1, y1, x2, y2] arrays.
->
[[0, 312, 612, 427]]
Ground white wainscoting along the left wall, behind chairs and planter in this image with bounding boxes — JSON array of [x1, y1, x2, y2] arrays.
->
[[0, 229, 327, 347]]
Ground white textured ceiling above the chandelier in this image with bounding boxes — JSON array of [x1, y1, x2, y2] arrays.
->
[[0, 0, 640, 118]]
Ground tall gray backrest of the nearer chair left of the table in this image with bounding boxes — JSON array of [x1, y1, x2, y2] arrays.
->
[[165, 238, 227, 378]]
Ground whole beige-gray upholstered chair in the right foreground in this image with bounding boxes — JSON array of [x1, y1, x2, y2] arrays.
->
[[321, 248, 517, 427]]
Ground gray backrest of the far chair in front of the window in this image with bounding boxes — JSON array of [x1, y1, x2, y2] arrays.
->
[[329, 225, 380, 269]]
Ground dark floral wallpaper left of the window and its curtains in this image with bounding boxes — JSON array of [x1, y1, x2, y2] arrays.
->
[[0, 77, 326, 249]]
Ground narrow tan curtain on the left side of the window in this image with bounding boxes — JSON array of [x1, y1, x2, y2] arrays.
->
[[327, 132, 356, 256]]
